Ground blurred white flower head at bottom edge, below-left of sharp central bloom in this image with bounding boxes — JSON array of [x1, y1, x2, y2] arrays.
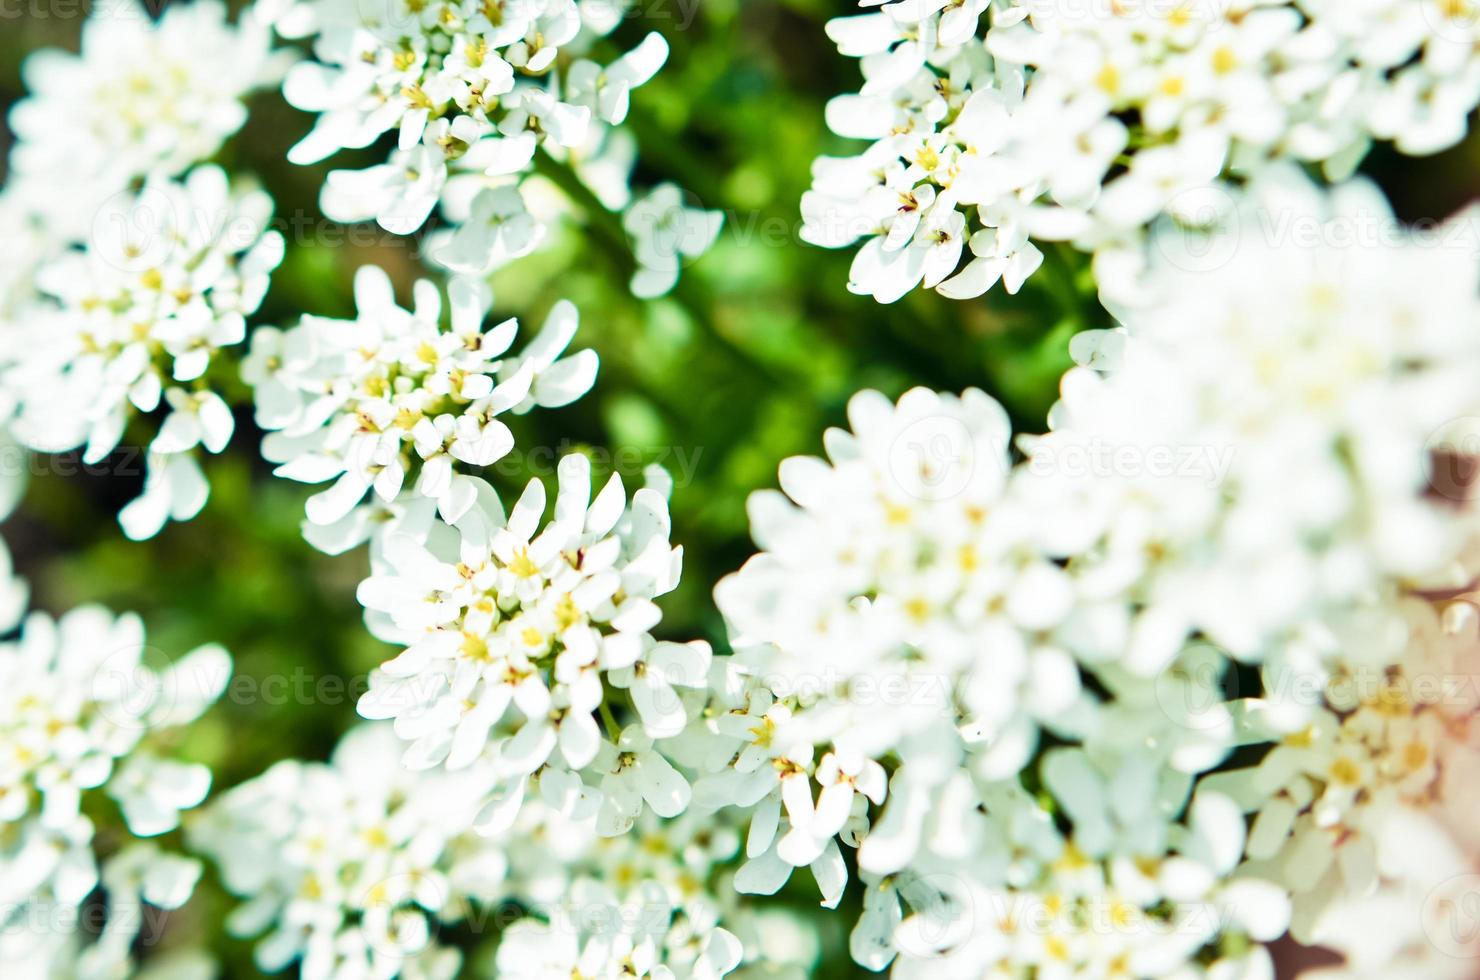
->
[[189, 725, 508, 979]]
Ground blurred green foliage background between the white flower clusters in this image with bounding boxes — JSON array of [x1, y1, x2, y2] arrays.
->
[[0, 0, 1480, 976]]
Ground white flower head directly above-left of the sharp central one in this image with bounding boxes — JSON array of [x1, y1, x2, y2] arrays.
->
[[241, 265, 596, 551]]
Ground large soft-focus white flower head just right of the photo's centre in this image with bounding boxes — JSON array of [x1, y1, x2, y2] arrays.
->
[[716, 378, 1079, 805]]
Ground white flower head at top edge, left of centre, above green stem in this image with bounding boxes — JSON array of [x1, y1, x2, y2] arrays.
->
[[275, 0, 667, 239]]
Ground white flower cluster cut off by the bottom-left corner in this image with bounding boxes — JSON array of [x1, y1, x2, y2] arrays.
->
[[0, 607, 231, 976]]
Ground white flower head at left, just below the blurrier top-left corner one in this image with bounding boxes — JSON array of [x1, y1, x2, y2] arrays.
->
[[4, 167, 284, 537]]
